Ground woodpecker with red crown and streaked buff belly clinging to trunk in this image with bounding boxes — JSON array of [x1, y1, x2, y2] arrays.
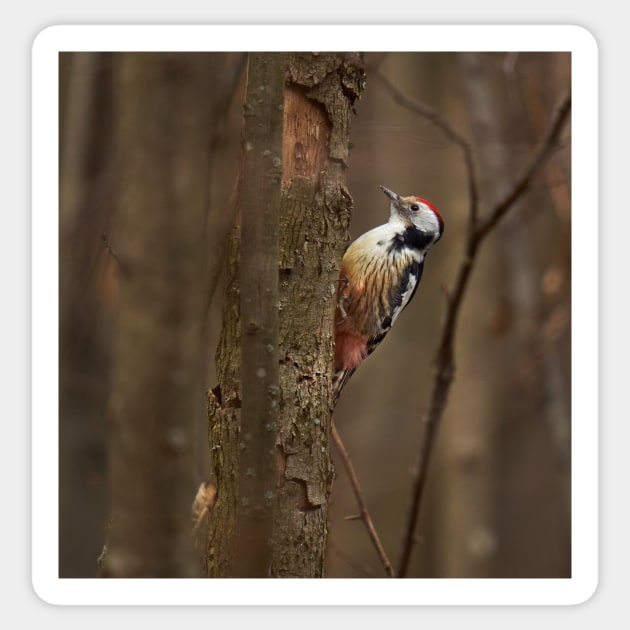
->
[[333, 186, 444, 404]]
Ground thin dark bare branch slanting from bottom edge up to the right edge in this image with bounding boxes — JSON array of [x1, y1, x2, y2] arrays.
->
[[396, 94, 571, 577]]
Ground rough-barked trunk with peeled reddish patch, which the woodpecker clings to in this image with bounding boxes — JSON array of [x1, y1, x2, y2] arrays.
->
[[206, 53, 364, 577]]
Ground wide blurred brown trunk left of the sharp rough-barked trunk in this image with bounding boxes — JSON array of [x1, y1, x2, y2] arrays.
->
[[103, 53, 230, 578]]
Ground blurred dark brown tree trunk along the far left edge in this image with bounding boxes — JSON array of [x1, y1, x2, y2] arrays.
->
[[59, 52, 116, 577]]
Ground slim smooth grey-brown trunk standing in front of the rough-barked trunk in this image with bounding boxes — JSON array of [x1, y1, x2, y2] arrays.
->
[[235, 53, 286, 577]]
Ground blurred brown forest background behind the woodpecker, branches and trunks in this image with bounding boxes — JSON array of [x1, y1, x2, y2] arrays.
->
[[59, 52, 571, 578]]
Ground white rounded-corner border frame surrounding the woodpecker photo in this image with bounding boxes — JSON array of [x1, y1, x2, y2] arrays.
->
[[32, 25, 598, 606]]
